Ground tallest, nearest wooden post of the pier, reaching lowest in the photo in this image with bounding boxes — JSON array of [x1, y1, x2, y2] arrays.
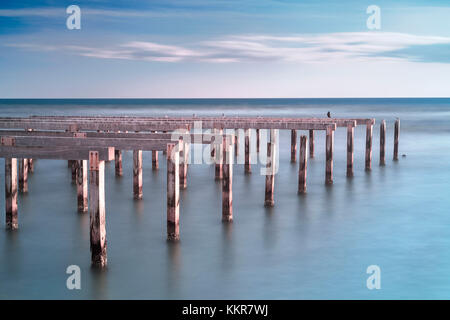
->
[[89, 151, 107, 268]]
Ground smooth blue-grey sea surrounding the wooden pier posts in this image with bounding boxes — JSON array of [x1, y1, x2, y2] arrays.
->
[[0, 99, 450, 299]]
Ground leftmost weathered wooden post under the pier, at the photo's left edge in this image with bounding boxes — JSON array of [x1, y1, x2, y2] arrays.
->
[[5, 158, 19, 230]]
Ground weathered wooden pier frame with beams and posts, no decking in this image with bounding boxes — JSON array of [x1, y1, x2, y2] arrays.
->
[[0, 116, 400, 267]]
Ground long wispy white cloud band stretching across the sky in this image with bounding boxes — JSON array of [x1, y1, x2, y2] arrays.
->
[[9, 32, 450, 63]]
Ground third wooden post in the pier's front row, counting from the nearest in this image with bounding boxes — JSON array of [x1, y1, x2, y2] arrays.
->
[[222, 137, 233, 222]]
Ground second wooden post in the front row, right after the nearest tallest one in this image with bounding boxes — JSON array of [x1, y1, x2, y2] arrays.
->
[[167, 143, 180, 241]]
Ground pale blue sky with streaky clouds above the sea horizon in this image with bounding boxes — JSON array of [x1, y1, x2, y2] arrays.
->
[[0, 0, 450, 98]]
